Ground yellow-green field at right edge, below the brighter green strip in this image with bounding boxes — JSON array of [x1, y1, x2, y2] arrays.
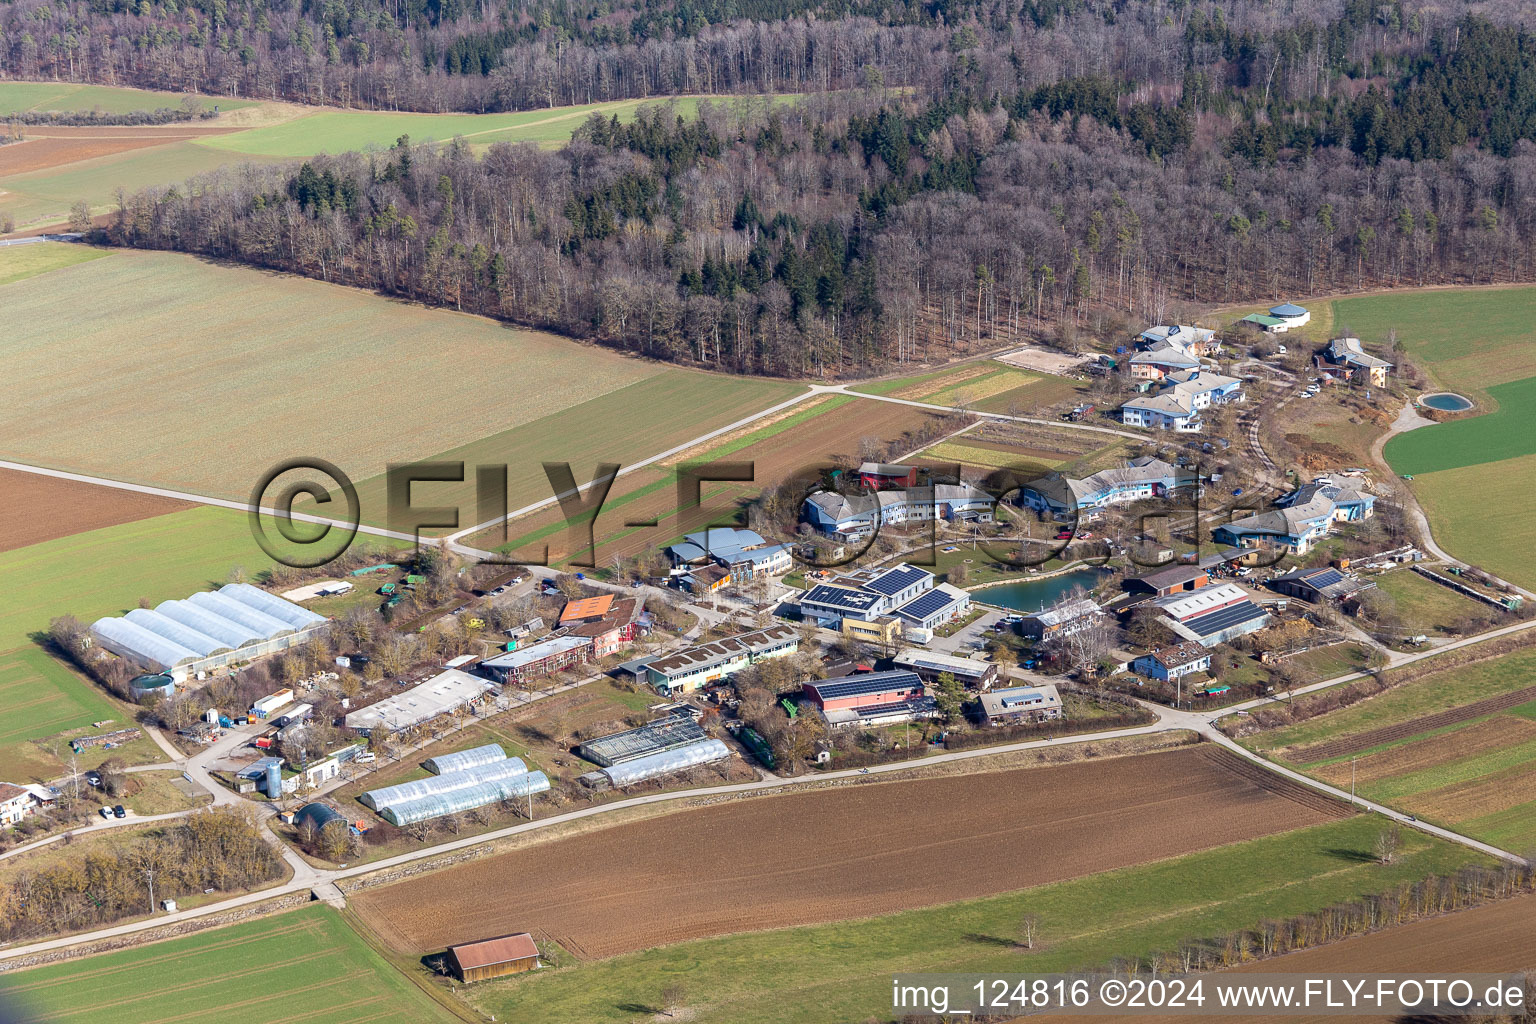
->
[[1410, 454, 1536, 588]]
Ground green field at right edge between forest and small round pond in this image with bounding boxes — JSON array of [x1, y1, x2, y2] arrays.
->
[[1333, 287, 1536, 390]]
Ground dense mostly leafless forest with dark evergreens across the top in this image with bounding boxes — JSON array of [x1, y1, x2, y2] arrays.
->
[[18, 0, 1536, 375]]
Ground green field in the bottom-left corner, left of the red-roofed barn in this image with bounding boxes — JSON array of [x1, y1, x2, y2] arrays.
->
[[0, 906, 456, 1024]]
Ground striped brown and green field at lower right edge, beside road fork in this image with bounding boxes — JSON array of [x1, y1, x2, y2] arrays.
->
[[1255, 651, 1536, 852]]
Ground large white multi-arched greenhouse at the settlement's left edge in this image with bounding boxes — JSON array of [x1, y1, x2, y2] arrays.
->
[[91, 583, 326, 683]]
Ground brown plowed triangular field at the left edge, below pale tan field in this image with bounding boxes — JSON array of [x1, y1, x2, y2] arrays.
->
[[0, 470, 190, 551]]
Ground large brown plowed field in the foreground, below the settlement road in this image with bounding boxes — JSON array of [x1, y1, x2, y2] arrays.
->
[[350, 746, 1349, 956]]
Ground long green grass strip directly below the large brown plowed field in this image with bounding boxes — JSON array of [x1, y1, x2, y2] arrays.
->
[[461, 815, 1476, 1024]]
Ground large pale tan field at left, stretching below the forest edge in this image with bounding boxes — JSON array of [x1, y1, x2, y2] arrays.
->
[[0, 252, 797, 503]]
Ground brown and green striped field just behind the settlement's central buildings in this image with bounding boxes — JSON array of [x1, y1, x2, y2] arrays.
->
[[475, 395, 934, 565]]
